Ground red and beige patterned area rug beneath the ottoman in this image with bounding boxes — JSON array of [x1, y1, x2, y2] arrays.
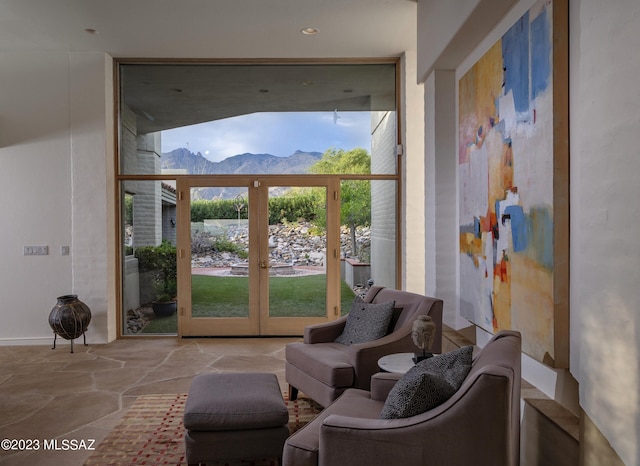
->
[[84, 394, 322, 466]]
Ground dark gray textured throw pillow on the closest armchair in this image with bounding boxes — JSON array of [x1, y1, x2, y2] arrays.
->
[[380, 346, 473, 419]]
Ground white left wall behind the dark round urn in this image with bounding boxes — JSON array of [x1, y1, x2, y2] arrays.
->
[[0, 52, 115, 344]]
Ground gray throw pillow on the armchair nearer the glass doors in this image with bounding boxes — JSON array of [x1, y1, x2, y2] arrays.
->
[[335, 296, 395, 346]]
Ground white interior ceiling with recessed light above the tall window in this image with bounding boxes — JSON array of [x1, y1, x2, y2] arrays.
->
[[0, 0, 417, 58]]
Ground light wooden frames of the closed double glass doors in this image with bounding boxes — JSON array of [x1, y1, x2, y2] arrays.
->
[[176, 175, 340, 337]]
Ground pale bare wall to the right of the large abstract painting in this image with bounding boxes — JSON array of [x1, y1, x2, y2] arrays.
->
[[569, 0, 640, 465]]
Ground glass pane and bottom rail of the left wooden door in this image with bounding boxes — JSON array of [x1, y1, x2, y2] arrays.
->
[[182, 183, 258, 336]]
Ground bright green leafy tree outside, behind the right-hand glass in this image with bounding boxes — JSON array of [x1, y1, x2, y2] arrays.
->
[[309, 148, 371, 255]]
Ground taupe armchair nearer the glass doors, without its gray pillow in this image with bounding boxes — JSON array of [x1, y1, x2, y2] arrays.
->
[[285, 286, 443, 406]]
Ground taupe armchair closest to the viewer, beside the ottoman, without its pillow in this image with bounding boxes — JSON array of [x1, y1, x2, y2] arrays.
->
[[283, 331, 521, 466]]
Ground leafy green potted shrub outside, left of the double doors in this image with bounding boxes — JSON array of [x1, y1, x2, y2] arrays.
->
[[136, 240, 178, 316]]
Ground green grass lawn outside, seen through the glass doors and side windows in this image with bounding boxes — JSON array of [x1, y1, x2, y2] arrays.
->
[[143, 274, 355, 333]]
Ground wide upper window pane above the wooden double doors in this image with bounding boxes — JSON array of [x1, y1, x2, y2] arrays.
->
[[120, 63, 397, 175]]
